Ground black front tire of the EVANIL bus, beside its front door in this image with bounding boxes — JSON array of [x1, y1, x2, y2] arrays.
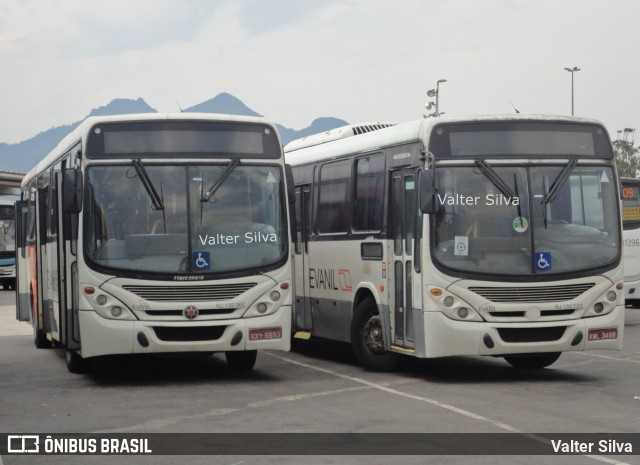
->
[[351, 297, 398, 371]]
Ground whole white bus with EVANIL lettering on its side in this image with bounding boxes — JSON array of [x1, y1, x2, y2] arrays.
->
[[285, 115, 624, 370]]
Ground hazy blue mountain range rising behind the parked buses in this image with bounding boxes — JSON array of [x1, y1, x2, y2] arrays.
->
[[0, 92, 348, 173]]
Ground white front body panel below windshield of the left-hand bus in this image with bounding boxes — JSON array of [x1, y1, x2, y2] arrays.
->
[[78, 264, 292, 358]]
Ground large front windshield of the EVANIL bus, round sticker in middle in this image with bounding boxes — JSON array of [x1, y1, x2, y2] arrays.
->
[[433, 163, 620, 277]]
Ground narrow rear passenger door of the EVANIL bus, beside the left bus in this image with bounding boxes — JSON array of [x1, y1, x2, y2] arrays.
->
[[294, 184, 313, 331]]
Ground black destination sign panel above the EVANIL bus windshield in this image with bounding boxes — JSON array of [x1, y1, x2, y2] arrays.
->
[[429, 120, 613, 159]]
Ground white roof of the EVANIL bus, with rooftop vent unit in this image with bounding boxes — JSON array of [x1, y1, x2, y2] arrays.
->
[[284, 113, 604, 166]]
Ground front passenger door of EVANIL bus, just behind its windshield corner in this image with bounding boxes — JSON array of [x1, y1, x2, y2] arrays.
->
[[389, 168, 417, 349]]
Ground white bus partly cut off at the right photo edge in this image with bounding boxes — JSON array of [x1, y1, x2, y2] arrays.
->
[[620, 178, 640, 307]]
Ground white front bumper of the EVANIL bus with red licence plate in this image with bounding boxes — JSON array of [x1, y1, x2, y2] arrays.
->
[[417, 306, 624, 358]]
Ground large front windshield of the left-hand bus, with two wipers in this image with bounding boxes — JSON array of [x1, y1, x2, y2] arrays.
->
[[84, 161, 287, 279]]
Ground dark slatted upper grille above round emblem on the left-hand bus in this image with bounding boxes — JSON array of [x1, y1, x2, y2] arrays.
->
[[122, 283, 257, 302]]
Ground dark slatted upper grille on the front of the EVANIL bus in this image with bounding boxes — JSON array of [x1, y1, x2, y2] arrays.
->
[[469, 283, 595, 303]]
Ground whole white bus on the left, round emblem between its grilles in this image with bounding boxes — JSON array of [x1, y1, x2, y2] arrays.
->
[[17, 113, 292, 372]]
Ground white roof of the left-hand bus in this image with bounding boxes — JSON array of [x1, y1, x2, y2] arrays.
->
[[22, 113, 280, 187]]
